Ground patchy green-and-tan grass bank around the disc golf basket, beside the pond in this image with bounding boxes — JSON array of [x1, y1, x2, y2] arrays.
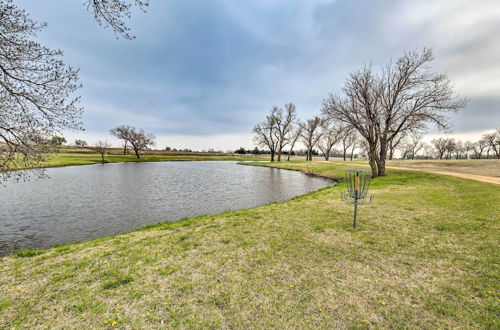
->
[[0, 162, 500, 328]]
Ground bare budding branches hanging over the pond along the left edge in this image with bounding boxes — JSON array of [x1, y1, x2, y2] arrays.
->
[[0, 0, 82, 180]]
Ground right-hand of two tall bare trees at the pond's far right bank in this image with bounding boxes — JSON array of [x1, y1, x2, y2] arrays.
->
[[271, 103, 297, 162]]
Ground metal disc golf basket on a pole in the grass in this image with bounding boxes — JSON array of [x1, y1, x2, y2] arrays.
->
[[340, 170, 373, 229]]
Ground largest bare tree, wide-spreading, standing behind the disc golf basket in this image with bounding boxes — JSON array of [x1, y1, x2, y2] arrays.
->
[[323, 49, 466, 176]]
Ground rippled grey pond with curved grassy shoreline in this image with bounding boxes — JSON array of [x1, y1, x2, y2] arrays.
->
[[0, 161, 332, 255]]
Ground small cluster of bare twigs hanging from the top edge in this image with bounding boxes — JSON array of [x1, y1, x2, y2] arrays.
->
[[86, 0, 149, 39]]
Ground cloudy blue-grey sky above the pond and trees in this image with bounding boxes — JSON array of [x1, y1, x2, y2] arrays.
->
[[15, 0, 500, 150]]
